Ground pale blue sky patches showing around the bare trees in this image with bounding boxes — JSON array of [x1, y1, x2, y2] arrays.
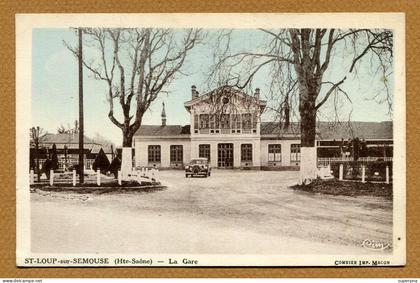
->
[[31, 29, 391, 145]]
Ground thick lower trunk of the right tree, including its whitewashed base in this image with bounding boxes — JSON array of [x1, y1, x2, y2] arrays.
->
[[299, 96, 318, 184]]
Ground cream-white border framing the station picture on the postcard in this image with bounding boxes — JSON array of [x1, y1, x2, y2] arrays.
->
[[16, 13, 406, 266]]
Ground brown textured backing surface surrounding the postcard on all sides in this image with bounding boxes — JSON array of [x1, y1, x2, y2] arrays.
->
[[0, 0, 420, 277]]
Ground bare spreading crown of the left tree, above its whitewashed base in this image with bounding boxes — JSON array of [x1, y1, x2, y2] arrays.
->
[[65, 28, 201, 147]]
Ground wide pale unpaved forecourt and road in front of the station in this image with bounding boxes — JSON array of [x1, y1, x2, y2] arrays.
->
[[31, 170, 392, 254]]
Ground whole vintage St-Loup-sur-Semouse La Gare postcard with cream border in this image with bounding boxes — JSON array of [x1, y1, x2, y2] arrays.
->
[[16, 13, 406, 267]]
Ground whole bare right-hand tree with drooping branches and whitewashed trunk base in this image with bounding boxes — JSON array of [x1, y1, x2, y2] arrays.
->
[[210, 29, 393, 183]]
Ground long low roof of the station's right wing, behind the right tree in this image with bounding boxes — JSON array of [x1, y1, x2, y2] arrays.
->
[[261, 121, 393, 140]]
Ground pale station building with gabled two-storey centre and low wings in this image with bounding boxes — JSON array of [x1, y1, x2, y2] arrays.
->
[[133, 86, 393, 170]]
